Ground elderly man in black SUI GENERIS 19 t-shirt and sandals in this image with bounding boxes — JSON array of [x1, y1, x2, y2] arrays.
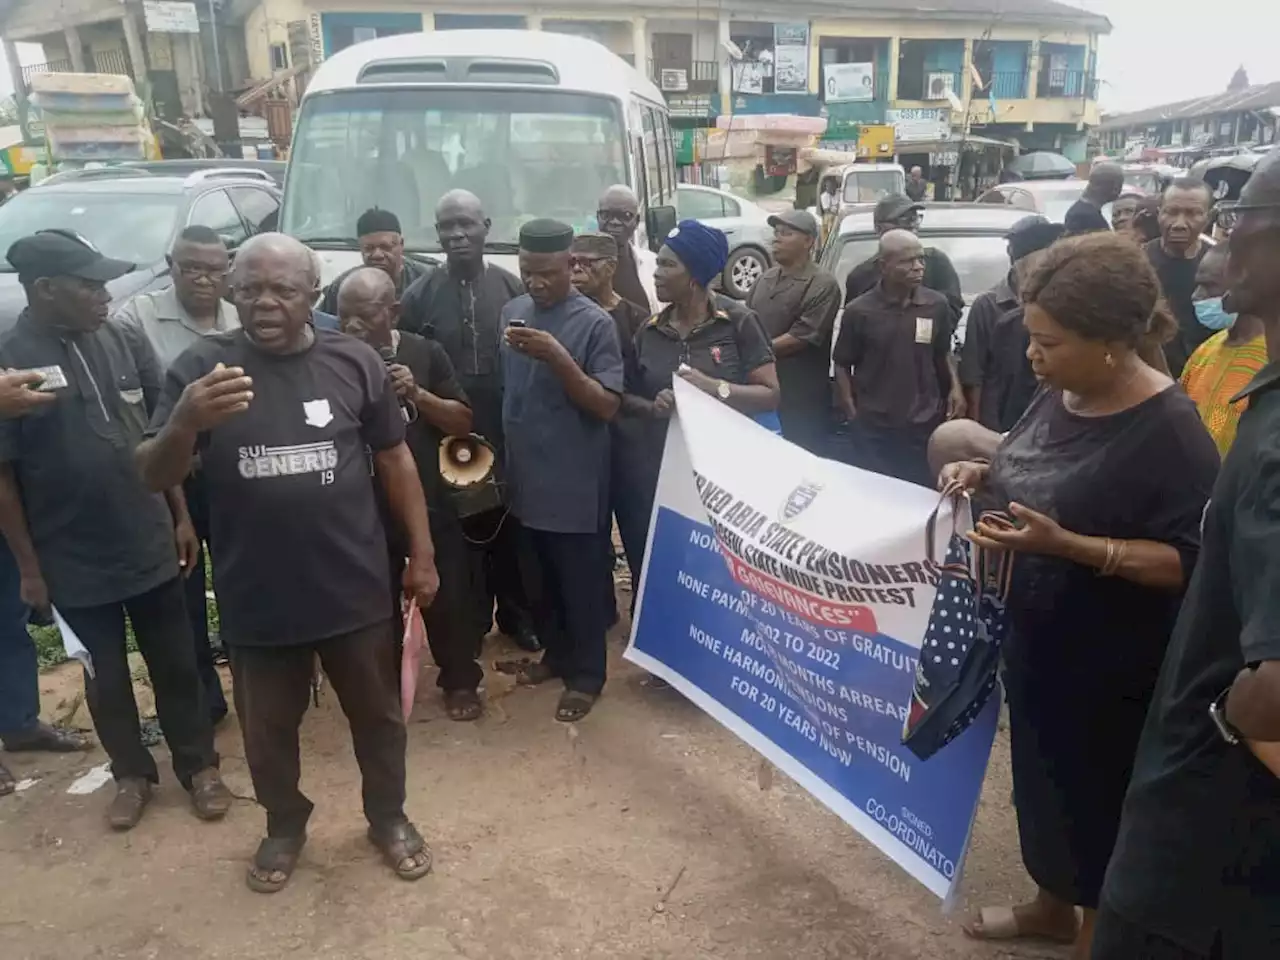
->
[[137, 233, 439, 893]]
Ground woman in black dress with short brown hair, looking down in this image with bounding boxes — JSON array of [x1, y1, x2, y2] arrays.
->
[[942, 233, 1219, 960]]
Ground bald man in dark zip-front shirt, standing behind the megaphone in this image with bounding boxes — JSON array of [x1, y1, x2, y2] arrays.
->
[[399, 189, 540, 653]]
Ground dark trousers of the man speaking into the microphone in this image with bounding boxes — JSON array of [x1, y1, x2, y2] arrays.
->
[[392, 511, 484, 691]]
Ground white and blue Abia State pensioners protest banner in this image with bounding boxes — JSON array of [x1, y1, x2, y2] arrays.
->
[[626, 378, 998, 897]]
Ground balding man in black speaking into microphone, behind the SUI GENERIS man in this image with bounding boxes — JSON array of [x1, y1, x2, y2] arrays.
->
[[338, 268, 484, 721]]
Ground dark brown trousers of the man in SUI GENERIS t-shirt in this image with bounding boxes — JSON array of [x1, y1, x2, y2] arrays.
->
[[229, 620, 406, 837]]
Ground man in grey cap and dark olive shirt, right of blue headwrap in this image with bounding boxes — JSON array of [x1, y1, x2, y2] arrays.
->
[[746, 210, 840, 456]]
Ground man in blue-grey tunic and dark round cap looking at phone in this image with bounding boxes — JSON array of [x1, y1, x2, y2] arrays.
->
[[502, 220, 623, 723]]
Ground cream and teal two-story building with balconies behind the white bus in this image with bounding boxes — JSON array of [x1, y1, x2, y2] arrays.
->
[[224, 0, 1110, 160]]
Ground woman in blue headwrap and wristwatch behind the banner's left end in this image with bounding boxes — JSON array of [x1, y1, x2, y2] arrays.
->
[[620, 220, 778, 555]]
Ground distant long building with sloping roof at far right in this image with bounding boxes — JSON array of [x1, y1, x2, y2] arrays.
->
[[1098, 81, 1280, 157]]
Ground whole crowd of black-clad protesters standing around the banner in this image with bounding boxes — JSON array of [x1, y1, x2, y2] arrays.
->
[[0, 142, 1280, 960]]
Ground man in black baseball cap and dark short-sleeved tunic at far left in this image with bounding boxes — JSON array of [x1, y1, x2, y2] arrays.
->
[[0, 230, 232, 829]]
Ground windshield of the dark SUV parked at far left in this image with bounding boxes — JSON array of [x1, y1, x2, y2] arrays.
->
[[0, 187, 182, 271]]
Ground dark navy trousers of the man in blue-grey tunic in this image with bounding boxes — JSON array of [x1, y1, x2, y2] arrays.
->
[[525, 527, 609, 694]]
